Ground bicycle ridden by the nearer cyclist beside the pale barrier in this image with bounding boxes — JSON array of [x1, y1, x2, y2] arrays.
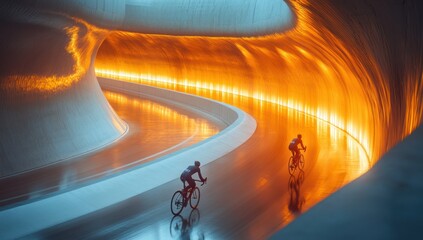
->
[[170, 179, 207, 216]]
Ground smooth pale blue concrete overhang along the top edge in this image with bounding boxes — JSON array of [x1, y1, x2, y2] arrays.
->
[[0, 0, 294, 36]]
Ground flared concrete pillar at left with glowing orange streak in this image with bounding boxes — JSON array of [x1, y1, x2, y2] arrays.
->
[[0, 1, 126, 177]]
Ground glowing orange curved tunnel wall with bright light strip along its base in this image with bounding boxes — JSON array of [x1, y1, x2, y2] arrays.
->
[[96, 1, 423, 163]]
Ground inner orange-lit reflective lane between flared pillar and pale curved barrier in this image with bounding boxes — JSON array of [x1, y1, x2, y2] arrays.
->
[[0, 90, 224, 208]]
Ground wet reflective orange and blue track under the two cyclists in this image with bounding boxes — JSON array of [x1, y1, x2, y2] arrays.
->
[[29, 86, 369, 239]]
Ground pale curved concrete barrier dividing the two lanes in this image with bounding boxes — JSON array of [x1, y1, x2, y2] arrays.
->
[[0, 79, 256, 239]]
